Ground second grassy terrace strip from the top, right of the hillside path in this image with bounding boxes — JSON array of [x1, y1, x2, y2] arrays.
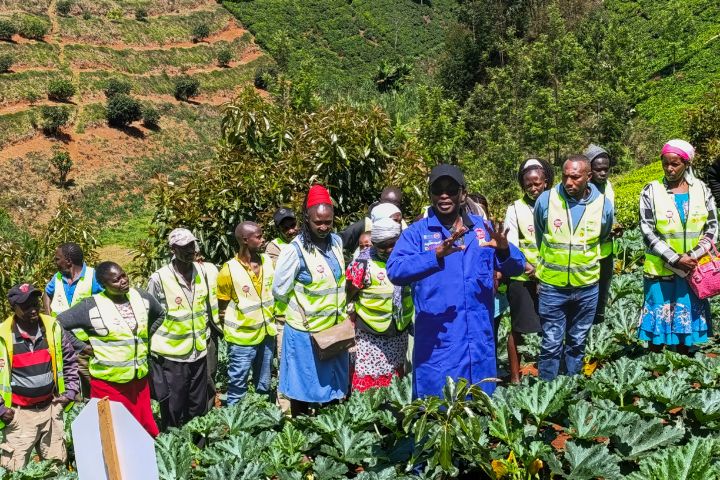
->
[[65, 34, 251, 74]]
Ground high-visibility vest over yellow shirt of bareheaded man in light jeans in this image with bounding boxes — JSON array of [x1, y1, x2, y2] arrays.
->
[[223, 254, 277, 345]]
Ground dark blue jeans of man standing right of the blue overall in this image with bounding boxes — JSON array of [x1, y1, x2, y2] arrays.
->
[[538, 283, 598, 380]]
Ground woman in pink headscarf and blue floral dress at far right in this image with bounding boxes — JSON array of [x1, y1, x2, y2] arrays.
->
[[638, 140, 717, 354]]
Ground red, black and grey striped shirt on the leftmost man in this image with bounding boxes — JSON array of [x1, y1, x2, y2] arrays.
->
[[10, 322, 55, 407]]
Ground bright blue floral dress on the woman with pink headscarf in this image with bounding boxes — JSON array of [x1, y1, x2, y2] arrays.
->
[[638, 193, 712, 346]]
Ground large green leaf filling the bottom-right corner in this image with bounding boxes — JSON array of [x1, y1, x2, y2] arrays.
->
[[627, 437, 718, 480]]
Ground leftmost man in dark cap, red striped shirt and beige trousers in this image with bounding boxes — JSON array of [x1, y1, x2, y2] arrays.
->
[[0, 283, 80, 470]]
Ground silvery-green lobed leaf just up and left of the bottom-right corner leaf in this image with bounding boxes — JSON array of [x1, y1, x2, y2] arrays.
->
[[612, 418, 685, 460]]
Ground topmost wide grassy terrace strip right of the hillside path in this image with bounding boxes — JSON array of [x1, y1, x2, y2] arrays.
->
[[59, 8, 231, 45]]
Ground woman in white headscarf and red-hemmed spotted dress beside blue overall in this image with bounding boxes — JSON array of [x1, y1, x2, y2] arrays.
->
[[346, 217, 415, 392]]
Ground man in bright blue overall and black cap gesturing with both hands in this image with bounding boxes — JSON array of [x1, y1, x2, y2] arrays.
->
[[387, 165, 525, 398]]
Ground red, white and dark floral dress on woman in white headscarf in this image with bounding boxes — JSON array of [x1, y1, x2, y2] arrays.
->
[[346, 249, 408, 392]]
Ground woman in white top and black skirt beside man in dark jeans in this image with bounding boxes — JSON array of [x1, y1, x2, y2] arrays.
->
[[505, 158, 554, 383]]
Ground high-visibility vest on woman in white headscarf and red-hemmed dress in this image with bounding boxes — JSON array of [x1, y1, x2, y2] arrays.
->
[[355, 259, 415, 333]]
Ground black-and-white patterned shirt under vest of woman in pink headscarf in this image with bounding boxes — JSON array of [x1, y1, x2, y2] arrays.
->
[[640, 178, 718, 278]]
